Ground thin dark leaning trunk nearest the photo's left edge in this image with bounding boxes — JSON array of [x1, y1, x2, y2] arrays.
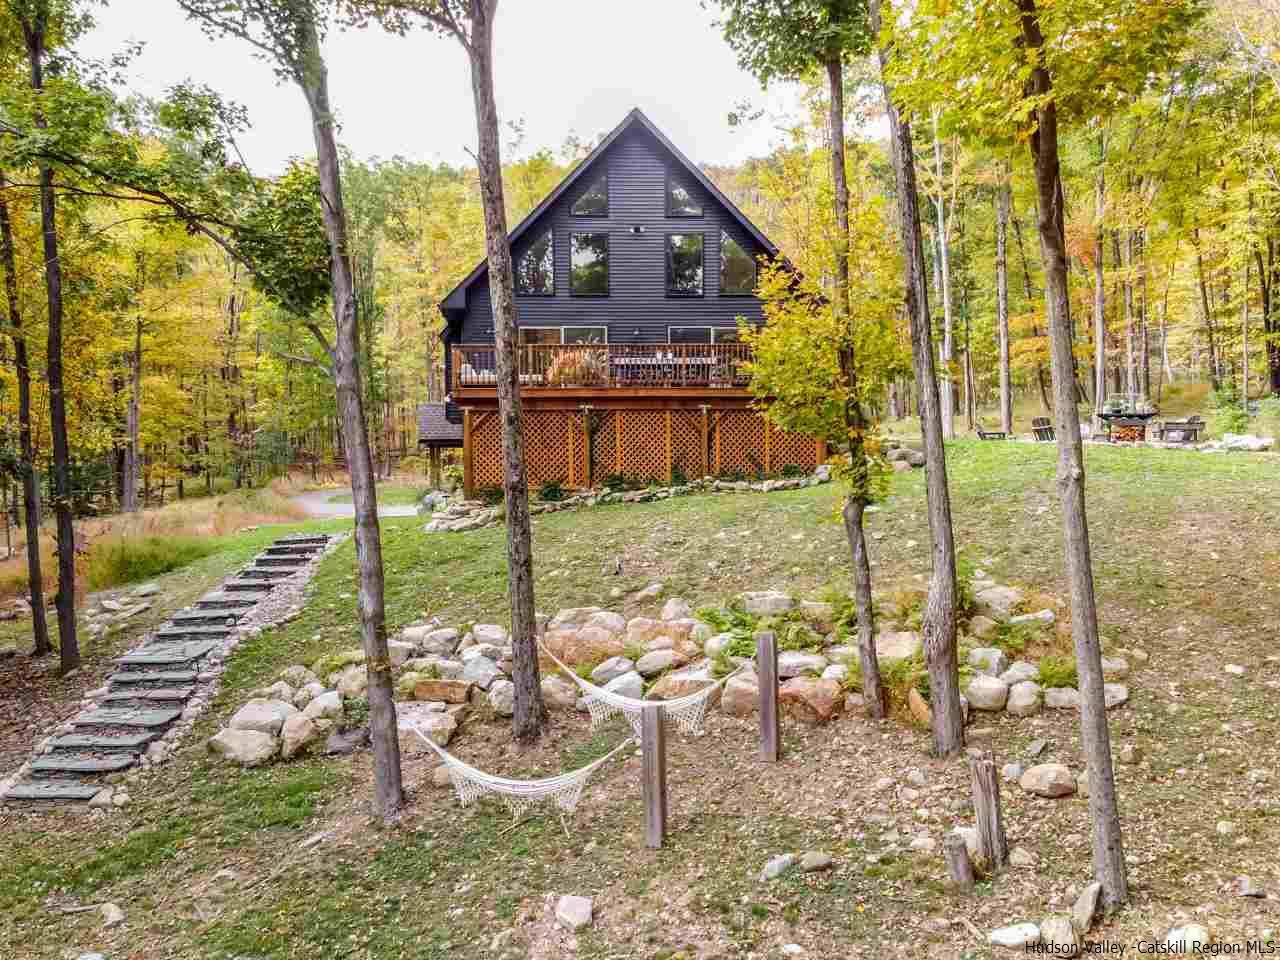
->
[[0, 173, 54, 657]]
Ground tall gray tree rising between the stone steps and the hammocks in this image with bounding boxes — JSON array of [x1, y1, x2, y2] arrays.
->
[[178, 0, 404, 822]]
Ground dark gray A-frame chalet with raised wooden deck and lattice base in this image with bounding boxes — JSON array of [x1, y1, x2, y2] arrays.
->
[[440, 110, 826, 492]]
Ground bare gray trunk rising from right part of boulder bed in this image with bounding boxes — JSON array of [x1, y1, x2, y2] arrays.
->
[[869, 0, 964, 756]]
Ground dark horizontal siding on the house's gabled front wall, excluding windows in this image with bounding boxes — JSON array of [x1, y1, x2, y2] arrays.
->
[[454, 127, 765, 343]]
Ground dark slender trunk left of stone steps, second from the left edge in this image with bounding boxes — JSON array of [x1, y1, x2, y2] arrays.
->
[[22, 16, 81, 673]]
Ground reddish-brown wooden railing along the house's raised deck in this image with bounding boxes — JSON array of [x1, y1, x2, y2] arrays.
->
[[453, 343, 751, 389]]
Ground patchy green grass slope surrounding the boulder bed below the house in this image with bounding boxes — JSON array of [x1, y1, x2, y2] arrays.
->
[[0, 442, 1280, 960]]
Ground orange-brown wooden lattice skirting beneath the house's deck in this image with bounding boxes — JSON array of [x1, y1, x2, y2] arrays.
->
[[463, 407, 826, 492]]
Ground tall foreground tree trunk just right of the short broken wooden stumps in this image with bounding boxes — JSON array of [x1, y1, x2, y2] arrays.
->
[[1018, 0, 1129, 910]]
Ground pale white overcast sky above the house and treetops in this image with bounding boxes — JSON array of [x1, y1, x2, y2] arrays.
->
[[81, 0, 796, 174]]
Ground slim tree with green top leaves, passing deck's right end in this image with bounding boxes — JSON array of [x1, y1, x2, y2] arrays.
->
[[722, 0, 886, 717]]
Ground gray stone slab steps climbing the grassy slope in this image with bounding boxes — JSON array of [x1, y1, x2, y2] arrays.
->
[[0, 534, 330, 809]]
